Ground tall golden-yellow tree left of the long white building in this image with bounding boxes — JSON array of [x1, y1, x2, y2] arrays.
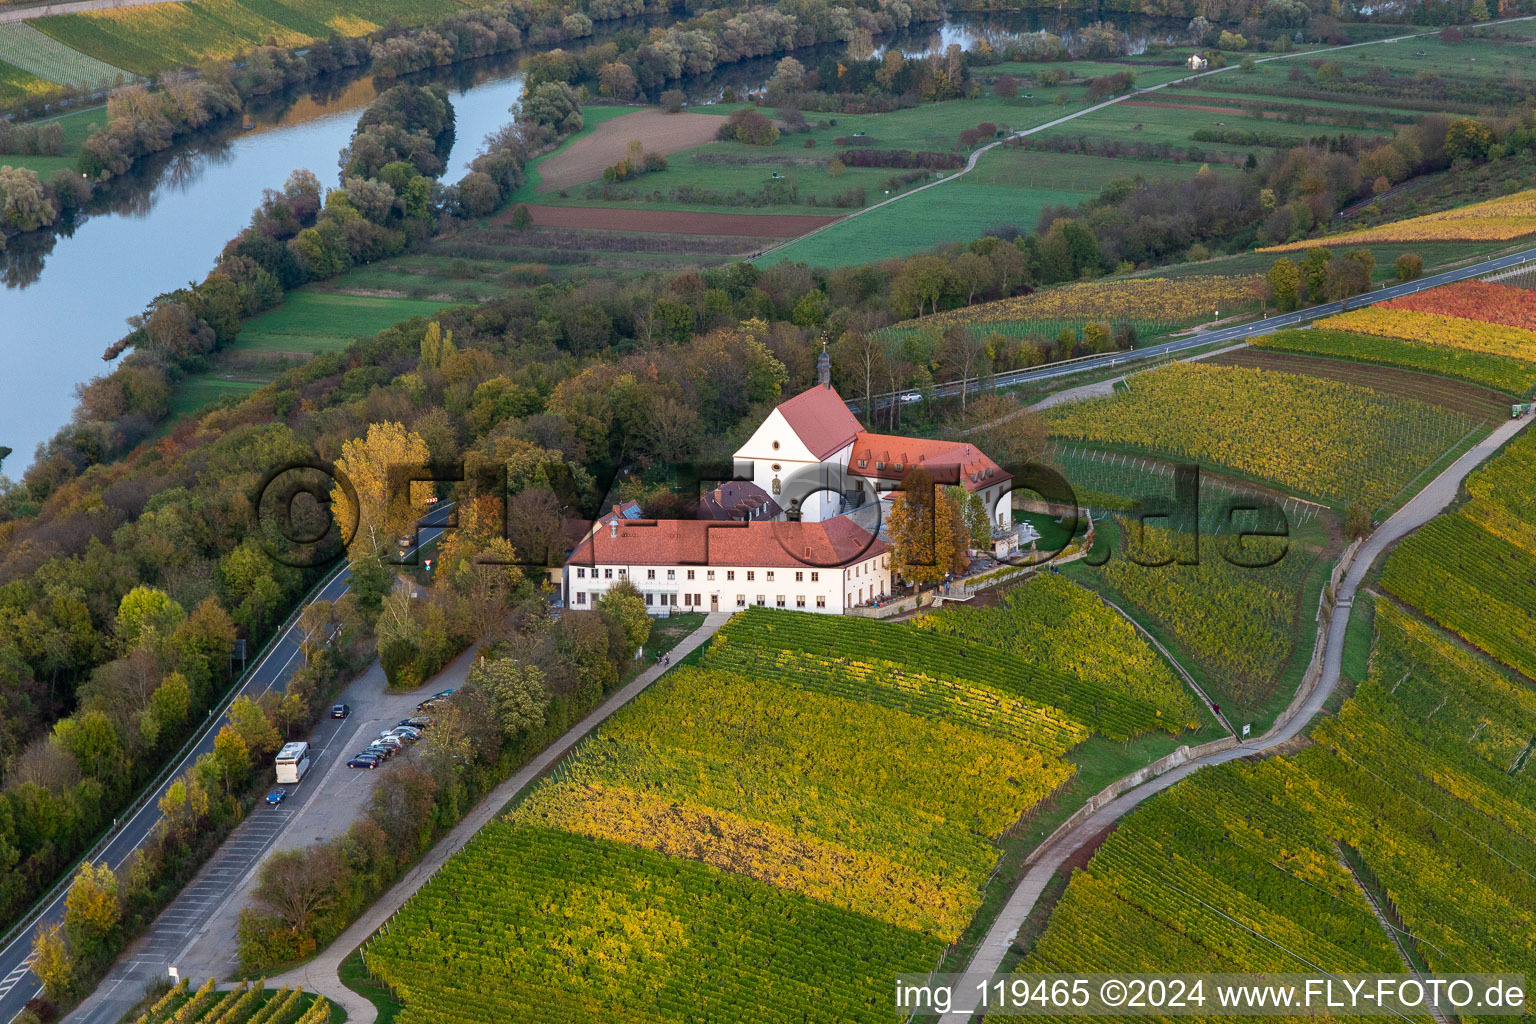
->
[[330, 422, 429, 556]]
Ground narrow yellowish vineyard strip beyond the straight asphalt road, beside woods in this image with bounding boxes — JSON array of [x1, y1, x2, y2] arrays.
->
[[909, 276, 1261, 329]]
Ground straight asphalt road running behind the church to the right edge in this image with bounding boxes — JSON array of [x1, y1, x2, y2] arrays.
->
[[852, 249, 1536, 411]]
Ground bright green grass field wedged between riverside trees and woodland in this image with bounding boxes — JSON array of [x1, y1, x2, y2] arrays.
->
[[232, 287, 452, 353]]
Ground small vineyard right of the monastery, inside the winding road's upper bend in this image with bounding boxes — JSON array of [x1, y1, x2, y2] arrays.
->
[[1092, 525, 1318, 711]]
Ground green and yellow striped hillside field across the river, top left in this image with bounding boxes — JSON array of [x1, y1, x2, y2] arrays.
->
[[31, 0, 461, 75]]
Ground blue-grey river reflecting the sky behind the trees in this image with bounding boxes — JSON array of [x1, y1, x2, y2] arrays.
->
[[0, 14, 1185, 477]]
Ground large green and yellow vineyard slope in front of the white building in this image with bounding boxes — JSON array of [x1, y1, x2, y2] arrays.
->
[[364, 607, 1198, 1024]]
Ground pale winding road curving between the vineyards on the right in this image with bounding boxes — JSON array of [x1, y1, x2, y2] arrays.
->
[[940, 416, 1531, 1024]]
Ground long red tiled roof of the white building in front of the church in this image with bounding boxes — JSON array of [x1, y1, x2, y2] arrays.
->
[[568, 513, 886, 570]]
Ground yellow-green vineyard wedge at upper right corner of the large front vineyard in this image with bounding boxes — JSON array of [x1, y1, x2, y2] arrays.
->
[[912, 573, 1200, 728]]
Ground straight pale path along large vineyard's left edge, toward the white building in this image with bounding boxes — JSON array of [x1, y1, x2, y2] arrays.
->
[[267, 611, 733, 1024]]
